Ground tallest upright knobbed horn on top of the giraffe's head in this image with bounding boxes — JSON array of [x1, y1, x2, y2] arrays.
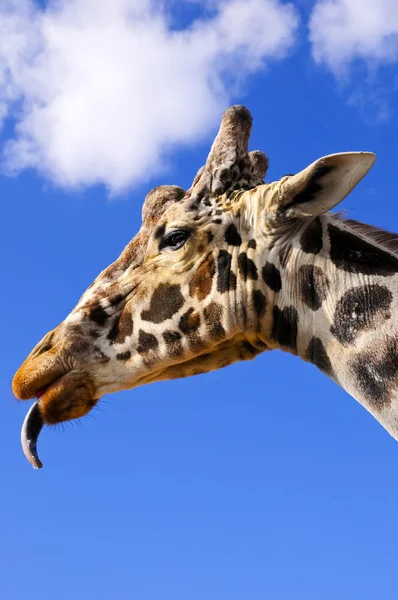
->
[[205, 104, 253, 172]]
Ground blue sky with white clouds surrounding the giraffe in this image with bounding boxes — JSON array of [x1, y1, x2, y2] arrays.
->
[[0, 0, 398, 600]]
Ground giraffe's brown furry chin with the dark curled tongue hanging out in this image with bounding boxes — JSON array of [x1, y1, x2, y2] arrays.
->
[[21, 373, 99, 469]]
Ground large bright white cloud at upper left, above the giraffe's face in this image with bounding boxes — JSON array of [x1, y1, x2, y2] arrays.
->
[[0, 0, 298, 192]]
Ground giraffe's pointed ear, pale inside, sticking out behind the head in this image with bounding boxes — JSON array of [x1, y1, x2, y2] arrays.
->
[[279, 152, 376, 218]]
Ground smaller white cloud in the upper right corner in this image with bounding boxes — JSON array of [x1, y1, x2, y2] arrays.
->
[[309, 0, 398, 75]]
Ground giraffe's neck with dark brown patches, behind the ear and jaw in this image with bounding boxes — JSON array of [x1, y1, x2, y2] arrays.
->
[[270, 214, 398, 437]]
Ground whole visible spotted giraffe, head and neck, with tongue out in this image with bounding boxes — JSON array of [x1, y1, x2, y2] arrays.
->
[[13, 105, 398, 468]]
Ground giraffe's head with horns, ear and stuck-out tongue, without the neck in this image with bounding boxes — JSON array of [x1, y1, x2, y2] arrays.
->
[[13, 106, 374, 466]]
